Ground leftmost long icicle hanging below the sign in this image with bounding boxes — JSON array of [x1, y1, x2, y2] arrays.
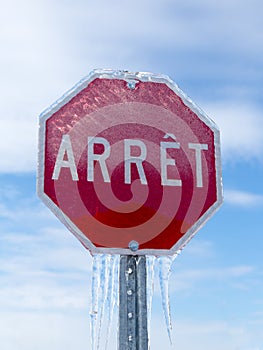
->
[[90, 255, 101, 350]]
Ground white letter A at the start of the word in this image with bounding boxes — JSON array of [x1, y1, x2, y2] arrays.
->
[[52, 135, 79, 181]]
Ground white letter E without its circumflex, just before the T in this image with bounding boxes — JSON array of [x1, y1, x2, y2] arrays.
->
[[160, 142, 182, 186]]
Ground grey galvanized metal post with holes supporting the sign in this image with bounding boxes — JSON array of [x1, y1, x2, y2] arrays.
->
[[118, 255, 148, 350]]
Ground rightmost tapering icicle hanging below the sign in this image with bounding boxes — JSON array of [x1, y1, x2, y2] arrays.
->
[[158, 256, 174, 345]]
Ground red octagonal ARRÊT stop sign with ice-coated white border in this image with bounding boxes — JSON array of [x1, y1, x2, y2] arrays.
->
[[38, 70, 222, 255]]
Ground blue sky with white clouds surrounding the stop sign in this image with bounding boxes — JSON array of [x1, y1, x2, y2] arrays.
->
[[0, 0, 263, 350]]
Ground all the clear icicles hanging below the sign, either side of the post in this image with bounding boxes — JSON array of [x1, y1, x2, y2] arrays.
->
[[90, 254, 176, 350]]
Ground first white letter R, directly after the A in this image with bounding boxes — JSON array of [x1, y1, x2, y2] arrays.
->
[[87, 137, 110, 182]]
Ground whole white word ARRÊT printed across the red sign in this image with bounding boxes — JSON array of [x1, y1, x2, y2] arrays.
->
[[52, 134, 208, 188]]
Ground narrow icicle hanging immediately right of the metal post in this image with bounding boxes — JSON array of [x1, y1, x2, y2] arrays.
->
[[146, 255, 156, 339]]
